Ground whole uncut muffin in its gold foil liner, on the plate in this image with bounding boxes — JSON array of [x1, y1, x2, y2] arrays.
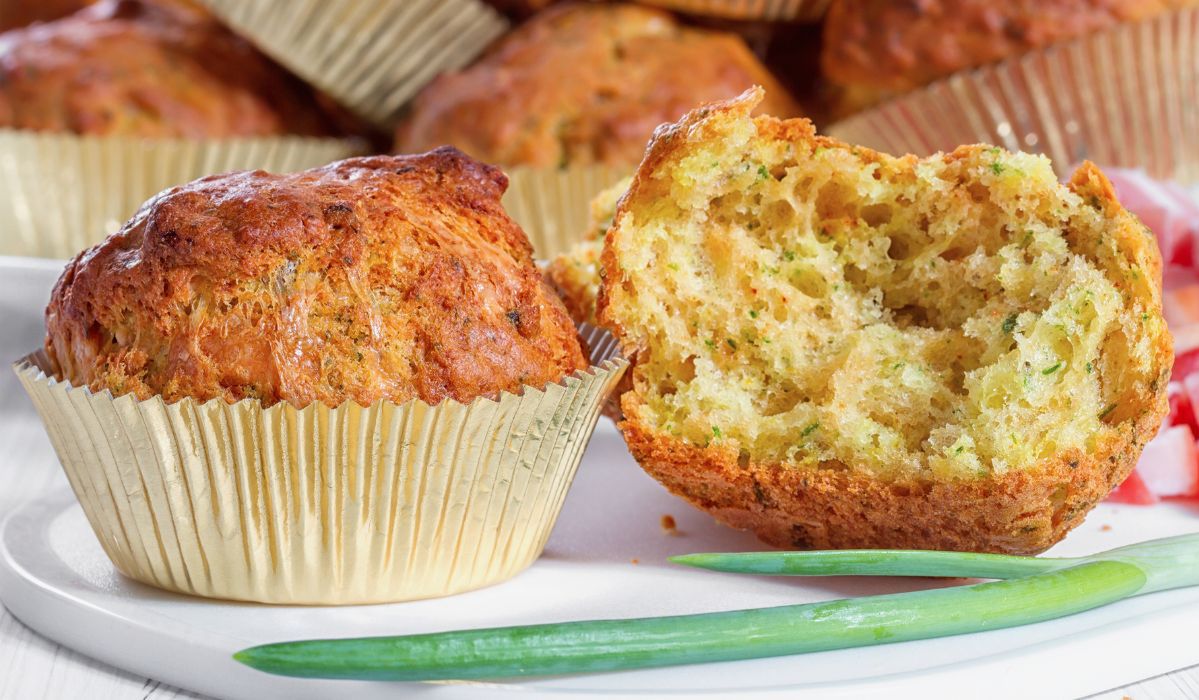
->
[[25, 147, 623, 604]]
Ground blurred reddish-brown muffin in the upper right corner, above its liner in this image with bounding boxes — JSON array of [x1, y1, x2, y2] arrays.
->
[[821, 0, 1197, 114]]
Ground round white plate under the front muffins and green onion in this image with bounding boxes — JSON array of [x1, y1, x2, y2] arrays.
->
[[0, 256, 1199, 699]]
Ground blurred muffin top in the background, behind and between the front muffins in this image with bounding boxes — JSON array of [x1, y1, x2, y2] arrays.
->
[[397, 5, 799, 167]]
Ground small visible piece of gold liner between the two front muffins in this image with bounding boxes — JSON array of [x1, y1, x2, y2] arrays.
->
[[504, 165, 632, 260]]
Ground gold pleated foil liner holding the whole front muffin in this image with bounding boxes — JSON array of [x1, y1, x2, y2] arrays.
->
[[14, 328, 627, 604]]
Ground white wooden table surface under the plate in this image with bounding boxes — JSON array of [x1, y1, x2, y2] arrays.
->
[[0, 263, 1199, 700]]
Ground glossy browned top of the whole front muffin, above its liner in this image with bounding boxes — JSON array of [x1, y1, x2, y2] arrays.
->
[[46, 147, 588, 406]]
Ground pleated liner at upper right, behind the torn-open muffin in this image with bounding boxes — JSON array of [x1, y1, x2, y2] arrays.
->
[[827, 8, 1199, 182]]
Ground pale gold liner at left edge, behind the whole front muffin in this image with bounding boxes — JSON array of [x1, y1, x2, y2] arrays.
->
[[0, 129, 362, 258]]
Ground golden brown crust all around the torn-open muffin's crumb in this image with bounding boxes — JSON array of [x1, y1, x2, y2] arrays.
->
[[597, 91, 1174, 554]]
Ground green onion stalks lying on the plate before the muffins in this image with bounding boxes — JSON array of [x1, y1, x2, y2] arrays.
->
[[234, 535, 1199, 681]]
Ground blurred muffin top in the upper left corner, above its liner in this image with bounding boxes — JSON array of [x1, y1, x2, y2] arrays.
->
[[0, 0, 333, 138]]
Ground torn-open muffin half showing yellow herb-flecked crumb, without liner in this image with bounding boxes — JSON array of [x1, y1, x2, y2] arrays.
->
[[597, 91, 1173, 554]]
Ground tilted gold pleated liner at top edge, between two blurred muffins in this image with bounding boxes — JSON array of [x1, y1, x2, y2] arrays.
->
[[201, 0, 508, 127]]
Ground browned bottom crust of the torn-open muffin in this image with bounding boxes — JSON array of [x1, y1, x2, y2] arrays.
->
[[620, 392, 1164, 555]]
